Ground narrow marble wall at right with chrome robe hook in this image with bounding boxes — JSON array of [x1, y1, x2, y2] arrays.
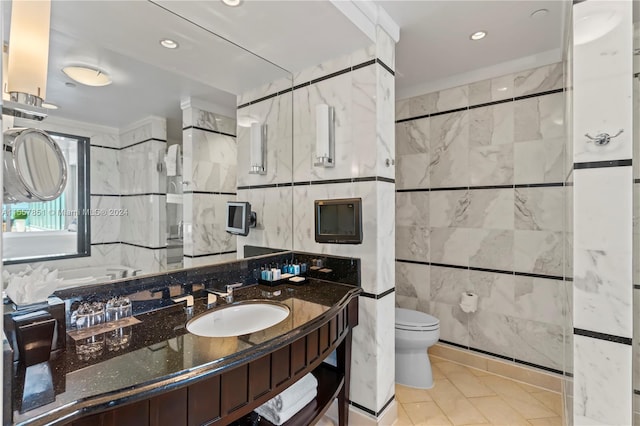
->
[[572, 0, 637, 425]]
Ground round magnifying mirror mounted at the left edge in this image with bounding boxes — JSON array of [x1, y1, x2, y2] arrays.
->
[[4, 129, 67, 203]]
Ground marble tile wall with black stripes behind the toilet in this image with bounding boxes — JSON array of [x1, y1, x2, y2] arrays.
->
[[396, 63, 570, 371]]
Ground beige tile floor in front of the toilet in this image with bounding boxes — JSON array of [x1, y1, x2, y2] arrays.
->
[[394, 356, 563, 426]]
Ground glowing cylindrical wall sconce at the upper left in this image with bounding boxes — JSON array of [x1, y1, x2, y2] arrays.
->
[[7, 0, 51, 107]]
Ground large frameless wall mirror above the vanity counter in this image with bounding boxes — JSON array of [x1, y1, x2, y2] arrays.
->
[[2, 1, 293, 288]]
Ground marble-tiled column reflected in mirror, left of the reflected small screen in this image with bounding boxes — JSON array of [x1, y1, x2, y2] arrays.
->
[[182, 103, 238, 266]]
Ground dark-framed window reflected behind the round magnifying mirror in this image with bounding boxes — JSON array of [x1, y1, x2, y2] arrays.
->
[[2, 132, 91, 264]]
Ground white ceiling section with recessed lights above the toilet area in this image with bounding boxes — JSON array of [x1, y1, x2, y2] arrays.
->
[[376, 0, 571, 98]]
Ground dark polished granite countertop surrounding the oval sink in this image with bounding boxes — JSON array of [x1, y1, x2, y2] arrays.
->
[[13, 280, 360, 425]]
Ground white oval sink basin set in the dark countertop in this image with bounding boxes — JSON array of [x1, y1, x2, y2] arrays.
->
[[187, 302, 289, 337]]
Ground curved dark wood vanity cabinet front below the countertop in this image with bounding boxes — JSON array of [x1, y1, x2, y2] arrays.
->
[[72, 297, 358, 426]]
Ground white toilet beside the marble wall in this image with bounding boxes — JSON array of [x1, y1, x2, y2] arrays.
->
[[396, 308, 440, 389]]
